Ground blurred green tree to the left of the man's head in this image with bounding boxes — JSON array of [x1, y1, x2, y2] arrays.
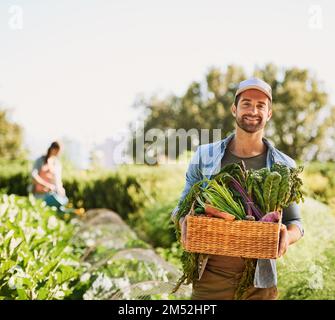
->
[[130, 66, 245, 162]]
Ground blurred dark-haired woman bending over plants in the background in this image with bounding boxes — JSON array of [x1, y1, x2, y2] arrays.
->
[[29, 141, 68, 211]]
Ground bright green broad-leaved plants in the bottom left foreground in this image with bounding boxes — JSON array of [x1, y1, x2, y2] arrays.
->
[[0, 195, 80, 300]]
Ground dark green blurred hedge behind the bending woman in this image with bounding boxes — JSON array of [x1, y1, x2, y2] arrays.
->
[[0, 161, 146, 218]]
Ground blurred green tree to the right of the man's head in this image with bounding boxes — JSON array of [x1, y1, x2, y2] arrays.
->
[[254, 64, 335, 160]]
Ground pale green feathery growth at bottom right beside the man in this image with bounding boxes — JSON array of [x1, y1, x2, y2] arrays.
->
[[278, 198, 335, 300]]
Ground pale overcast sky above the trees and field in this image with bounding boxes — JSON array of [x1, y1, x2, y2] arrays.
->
[[0, 0, 335, 158]]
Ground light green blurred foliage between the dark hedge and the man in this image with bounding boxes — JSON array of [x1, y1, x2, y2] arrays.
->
[[119, 161, 187, 248]]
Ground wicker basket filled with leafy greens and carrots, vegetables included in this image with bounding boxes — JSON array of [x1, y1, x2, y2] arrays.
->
[[179, 162, 302, 259]]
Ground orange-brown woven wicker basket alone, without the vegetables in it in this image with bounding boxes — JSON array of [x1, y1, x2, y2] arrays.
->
[[183, 206, 282, 259]]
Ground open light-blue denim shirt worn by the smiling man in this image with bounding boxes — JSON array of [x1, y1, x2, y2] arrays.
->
[[171, 133, 304, 288]]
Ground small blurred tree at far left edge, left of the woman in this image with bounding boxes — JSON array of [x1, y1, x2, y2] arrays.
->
[[0, 110, 24, 160]]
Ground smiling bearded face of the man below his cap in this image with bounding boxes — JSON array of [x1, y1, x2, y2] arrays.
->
[[232, 89, 272, 133]]
